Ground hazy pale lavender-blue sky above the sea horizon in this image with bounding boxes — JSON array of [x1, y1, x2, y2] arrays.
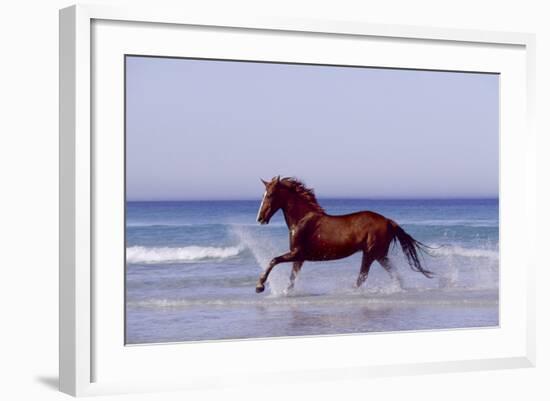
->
[[126, 56, 499, 201]]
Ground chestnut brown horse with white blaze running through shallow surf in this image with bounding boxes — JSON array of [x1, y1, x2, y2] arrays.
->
[[256, 177, 433, 293]]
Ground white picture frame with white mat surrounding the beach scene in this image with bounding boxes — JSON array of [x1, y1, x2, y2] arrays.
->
[[60, 5, 537, 395]]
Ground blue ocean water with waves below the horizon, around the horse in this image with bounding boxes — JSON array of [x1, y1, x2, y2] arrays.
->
[[126, 199, 499, 344]]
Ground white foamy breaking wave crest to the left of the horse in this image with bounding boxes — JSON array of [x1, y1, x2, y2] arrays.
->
[[126, 246, 243, 263]]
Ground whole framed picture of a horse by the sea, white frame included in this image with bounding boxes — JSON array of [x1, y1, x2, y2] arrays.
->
[[60, 6, 536, 395]]
